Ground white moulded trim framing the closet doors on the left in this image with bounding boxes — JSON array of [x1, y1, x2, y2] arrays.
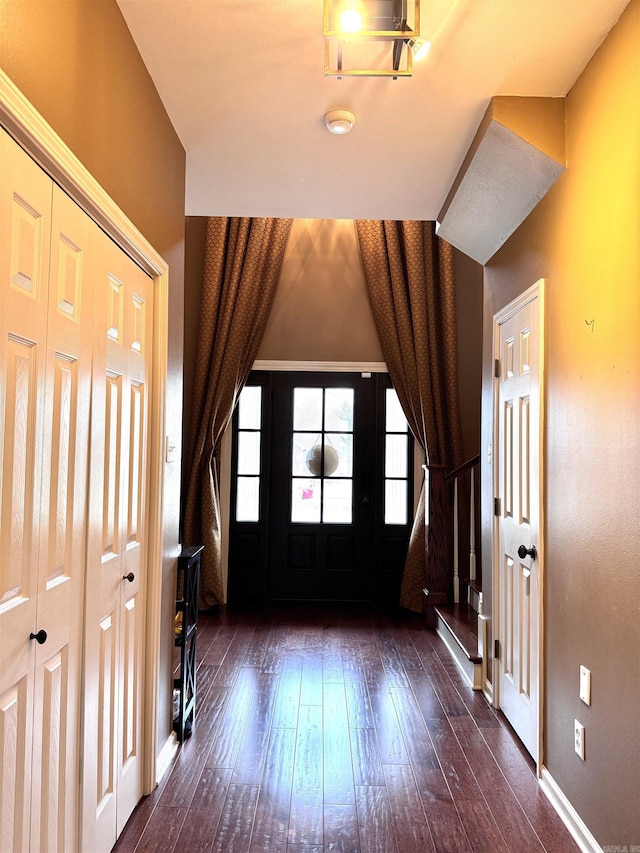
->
[[0, 70, 169, 793]]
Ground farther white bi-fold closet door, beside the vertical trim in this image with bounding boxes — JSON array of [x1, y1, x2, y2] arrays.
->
[[82, 223, 152, 853]]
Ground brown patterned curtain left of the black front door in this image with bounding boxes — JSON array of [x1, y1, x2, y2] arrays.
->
[[183, 216, 293, 608]]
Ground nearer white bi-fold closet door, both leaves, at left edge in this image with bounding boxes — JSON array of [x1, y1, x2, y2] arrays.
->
[[0, 132, 97, 851]]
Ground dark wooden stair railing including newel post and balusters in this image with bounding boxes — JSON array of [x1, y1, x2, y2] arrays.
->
[[423, 455, 480, 629]]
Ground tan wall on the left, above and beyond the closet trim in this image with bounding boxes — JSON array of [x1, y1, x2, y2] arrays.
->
[[0, 0, 185, 760]]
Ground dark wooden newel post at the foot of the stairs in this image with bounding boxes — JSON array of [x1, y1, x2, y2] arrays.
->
[[423, 465, 452, 630]]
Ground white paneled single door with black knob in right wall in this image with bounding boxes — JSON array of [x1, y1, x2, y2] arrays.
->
[[494, 283, 542, 761]]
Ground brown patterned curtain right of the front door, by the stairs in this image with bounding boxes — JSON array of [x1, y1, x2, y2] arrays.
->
[[356, 220, 463, 613]]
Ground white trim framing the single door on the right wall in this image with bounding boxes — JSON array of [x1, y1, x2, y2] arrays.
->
[[491, 278, 546, 778]]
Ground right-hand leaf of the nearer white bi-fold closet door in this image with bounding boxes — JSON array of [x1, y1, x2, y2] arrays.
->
[[31, 186, 97, 851]]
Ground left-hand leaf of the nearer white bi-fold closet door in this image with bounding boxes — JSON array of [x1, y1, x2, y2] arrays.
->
[[0, 132, 52, 850]]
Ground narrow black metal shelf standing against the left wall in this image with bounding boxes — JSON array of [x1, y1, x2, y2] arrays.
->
[[173, 545, 204, 743]]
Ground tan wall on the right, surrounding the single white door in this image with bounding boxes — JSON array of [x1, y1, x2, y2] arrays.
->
[[482, 0, 640, 849]]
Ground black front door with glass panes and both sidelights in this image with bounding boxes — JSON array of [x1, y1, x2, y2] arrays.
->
[[230, 372, 413, 601]]
